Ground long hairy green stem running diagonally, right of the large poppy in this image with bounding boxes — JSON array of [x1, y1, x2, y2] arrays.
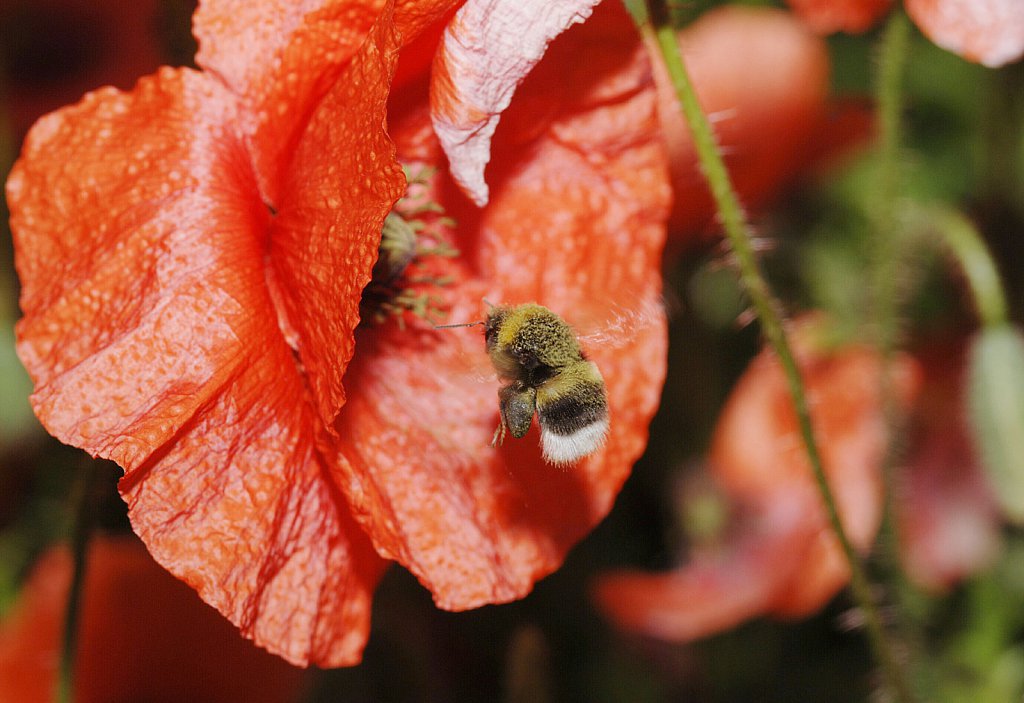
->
[[643, 6, 913, 703]]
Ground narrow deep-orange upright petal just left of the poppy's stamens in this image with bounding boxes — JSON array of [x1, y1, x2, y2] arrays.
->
[[270, 12, 406, 427]]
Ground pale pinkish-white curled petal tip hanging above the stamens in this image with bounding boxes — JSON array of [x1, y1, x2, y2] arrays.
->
[[430, 0, 599, 206]]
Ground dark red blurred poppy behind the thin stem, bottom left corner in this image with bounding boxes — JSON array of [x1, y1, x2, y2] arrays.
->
[[0, 537, 304, 703]]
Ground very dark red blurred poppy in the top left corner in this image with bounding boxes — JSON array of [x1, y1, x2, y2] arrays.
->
[[0, 0, 161, 139]]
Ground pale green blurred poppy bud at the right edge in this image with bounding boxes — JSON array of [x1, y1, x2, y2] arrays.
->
[[969, 324, 1024, 524]]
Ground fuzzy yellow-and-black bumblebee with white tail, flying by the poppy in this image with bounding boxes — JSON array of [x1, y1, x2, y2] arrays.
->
[[483, 303, 608, 465]]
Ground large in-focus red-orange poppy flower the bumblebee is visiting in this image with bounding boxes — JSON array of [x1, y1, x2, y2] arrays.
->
[[7, 0, 669, 666]]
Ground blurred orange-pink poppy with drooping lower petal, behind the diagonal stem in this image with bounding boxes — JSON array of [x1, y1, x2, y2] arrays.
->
[[596, 321, 918, 641]]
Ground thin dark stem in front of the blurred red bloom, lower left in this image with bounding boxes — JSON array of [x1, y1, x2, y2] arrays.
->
[[55, 460, 97, 703]]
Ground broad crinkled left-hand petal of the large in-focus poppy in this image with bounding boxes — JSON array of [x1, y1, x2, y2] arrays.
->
[[7, 70, 382, 664]]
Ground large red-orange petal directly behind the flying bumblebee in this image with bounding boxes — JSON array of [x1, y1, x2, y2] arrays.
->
[[337, 5, 669, 609]]
